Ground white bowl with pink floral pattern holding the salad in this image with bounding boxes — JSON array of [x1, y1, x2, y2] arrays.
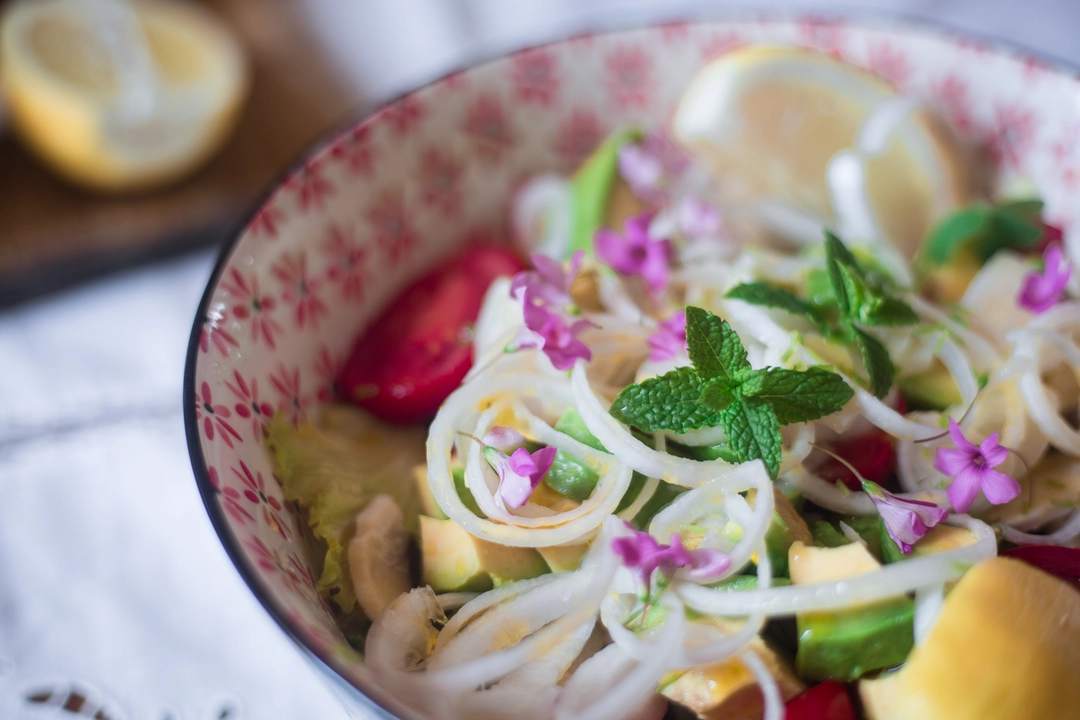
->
[[185, 18, 1080, 714]]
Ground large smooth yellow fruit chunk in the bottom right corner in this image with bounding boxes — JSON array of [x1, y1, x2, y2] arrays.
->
[[859, 558, 1080, 720]]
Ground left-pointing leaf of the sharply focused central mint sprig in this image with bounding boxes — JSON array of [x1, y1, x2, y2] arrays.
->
[[611, 367, 720, 433]]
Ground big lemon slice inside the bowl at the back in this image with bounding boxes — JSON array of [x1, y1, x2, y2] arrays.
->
[[672, 46, 970, 258]]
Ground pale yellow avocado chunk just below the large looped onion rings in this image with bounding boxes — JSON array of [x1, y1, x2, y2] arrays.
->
[[420, 515, 550, 593]]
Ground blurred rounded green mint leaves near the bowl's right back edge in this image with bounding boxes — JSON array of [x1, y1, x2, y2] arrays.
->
[[922, 200, 1042, 266]]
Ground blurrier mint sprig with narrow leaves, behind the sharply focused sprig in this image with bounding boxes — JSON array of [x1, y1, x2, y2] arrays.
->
[[727, 231, 919, 397]]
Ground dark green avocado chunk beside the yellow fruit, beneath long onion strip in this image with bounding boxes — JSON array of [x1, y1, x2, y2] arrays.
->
[[795, 597, 915, 682]]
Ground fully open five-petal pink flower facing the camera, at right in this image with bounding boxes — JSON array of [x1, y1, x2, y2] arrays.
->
[[934, 418, 1021, 513]]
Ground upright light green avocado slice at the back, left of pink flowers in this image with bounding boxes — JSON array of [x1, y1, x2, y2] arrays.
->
[[567, 128, 642, 255]]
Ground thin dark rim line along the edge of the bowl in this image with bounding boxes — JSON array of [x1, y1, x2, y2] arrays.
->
[[183, 8, 1080, 718]]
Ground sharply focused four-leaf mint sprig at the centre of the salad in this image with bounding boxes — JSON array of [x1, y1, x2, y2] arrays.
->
[[611, 307, 854, 477]]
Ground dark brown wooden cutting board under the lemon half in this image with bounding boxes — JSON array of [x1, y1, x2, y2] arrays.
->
[[0, 0, 360, 307]]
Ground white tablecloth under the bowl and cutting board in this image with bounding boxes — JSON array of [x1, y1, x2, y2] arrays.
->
[[0, 0, 1080, 720]]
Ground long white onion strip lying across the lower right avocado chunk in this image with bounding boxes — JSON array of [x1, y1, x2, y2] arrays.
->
[[676, 515, 997, 616]]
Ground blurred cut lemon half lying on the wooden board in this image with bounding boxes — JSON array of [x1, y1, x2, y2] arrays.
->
[[0, 0, 248, 191]]
